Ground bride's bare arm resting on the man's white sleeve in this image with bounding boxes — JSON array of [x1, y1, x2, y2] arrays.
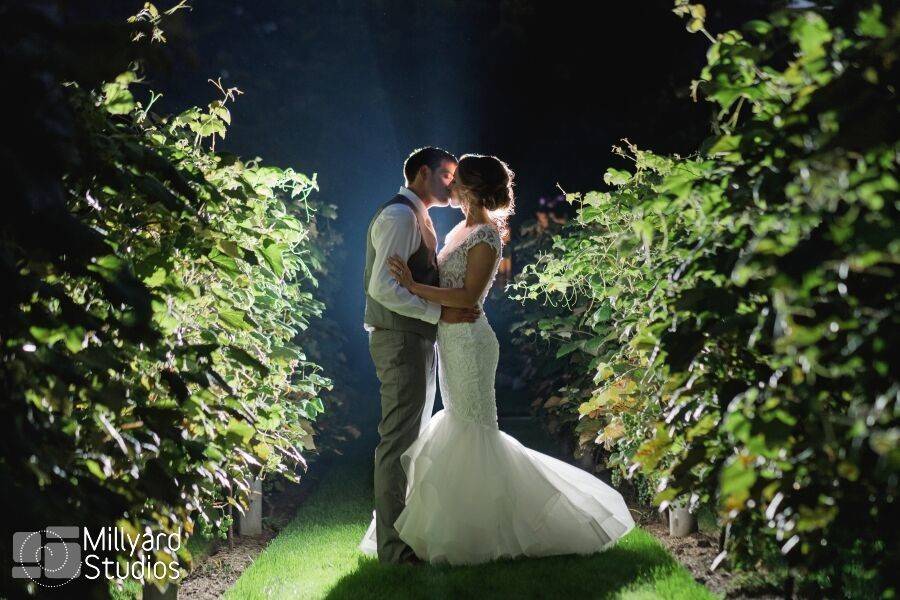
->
[[388, 242, 497, 308]]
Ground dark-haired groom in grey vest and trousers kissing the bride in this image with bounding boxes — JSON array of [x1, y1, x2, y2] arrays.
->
[[365, 147, 478, 563]]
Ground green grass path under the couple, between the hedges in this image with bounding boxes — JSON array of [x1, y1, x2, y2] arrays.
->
[[225, 424, 712, 600]]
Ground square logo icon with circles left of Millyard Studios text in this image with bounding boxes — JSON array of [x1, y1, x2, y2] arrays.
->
[[12, 526, 81, 587]]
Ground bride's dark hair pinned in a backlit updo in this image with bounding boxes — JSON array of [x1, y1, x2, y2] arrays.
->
[[455, 154, 515, 241]]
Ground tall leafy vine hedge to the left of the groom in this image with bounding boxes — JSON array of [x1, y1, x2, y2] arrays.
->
[[0, 2, 333, 595]]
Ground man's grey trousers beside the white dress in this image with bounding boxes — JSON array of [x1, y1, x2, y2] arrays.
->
[[369, 329, 436, 563]]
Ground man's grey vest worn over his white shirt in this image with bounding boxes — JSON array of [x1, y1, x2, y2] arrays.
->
[[364, 194, 439, 340]]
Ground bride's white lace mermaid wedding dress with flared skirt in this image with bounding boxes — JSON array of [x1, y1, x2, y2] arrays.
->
[[359, 222, 634, 565]]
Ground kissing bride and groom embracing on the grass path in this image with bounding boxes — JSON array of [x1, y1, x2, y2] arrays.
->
[[359, 147, 634, 565]]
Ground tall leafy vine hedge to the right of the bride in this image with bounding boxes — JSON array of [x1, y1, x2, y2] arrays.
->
[[516, 0, 900, 597]]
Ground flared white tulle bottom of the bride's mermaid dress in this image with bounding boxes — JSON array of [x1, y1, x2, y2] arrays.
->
[[359, 409, 634, 565]]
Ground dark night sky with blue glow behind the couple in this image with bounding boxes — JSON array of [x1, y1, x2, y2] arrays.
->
[[70, 0, 767, 414]]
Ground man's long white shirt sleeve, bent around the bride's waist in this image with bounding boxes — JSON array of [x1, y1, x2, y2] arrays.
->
[[368, 204, 441, 323]]
